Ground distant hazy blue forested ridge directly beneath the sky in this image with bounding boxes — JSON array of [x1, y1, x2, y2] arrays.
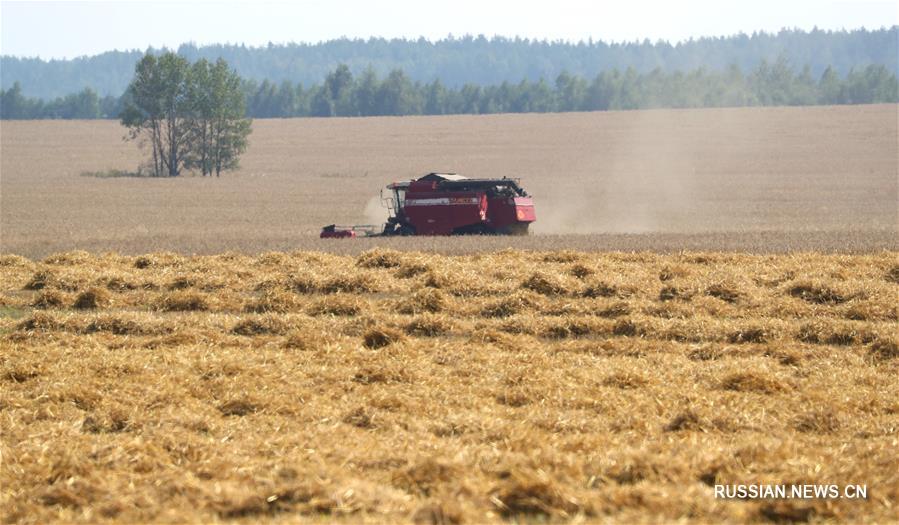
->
[[0, 26, 899, 101]]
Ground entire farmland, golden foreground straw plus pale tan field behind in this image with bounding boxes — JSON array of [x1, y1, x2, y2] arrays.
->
[[0, 105, 899, 523]]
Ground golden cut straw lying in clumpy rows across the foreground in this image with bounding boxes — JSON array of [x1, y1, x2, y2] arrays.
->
[[0, 251, 899, 523]]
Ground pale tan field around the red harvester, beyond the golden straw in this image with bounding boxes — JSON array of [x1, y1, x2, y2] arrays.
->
[[0, 105, 899, 258]]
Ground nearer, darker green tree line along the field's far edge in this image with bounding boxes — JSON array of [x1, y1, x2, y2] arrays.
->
[[0, 59, 899, 119]]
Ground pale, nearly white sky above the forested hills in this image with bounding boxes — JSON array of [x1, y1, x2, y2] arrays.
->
[[0, 0, 899, 59]]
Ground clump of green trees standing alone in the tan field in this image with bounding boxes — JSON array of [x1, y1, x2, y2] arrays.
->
[[120, 53, 251, 177]]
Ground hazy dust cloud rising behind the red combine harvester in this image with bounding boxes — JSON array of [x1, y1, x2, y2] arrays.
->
[[532, 112, 706, 234]]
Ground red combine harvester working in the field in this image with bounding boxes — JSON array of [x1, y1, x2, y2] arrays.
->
[[320, 173, 537, 239]]
